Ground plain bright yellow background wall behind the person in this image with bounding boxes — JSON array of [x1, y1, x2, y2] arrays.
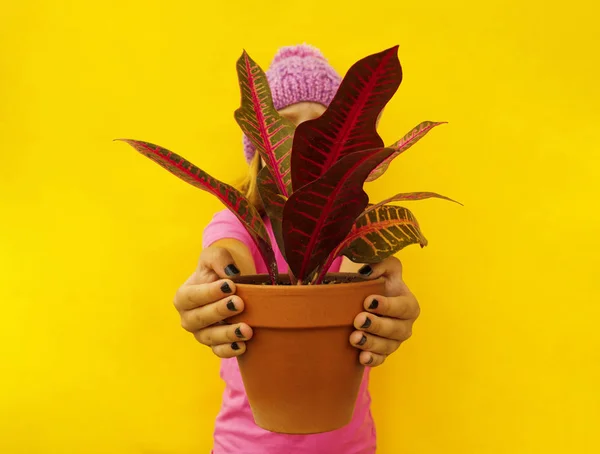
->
[[0, 0, 600, 454]]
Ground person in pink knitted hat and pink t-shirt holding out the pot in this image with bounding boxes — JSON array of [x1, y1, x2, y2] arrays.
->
[[175, 45, 419, 454]]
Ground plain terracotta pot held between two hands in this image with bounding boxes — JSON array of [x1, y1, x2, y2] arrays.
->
[[229, 273, 384, 434]]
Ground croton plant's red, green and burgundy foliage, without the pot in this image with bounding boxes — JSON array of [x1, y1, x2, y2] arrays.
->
[[124, 46, 460, 285]]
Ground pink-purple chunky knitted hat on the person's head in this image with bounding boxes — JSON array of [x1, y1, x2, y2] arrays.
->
[[244, 44, 342, 163]]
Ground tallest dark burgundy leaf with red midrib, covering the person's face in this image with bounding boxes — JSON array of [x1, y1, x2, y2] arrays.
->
[[292, 46, 402, 190]]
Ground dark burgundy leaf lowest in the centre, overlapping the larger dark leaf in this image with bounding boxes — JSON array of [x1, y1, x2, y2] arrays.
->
[[283, 148, 394, 282]]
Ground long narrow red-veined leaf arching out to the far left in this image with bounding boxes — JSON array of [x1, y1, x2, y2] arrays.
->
[[119, 139, 277, 283]]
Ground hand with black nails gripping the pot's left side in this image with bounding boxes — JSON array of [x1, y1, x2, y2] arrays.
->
[[173, 246, 252, 358]]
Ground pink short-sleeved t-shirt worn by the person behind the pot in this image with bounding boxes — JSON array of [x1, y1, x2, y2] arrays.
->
[[202, 210, 376, 454]]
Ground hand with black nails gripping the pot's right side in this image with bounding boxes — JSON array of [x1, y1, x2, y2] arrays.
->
[[350, 257, 420, 367]]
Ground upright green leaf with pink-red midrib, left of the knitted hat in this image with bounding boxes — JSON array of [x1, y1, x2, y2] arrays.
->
[[235, 51, 295, 197]]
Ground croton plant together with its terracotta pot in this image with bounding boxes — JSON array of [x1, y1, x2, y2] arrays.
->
[[119, 46, 462, 433]]
